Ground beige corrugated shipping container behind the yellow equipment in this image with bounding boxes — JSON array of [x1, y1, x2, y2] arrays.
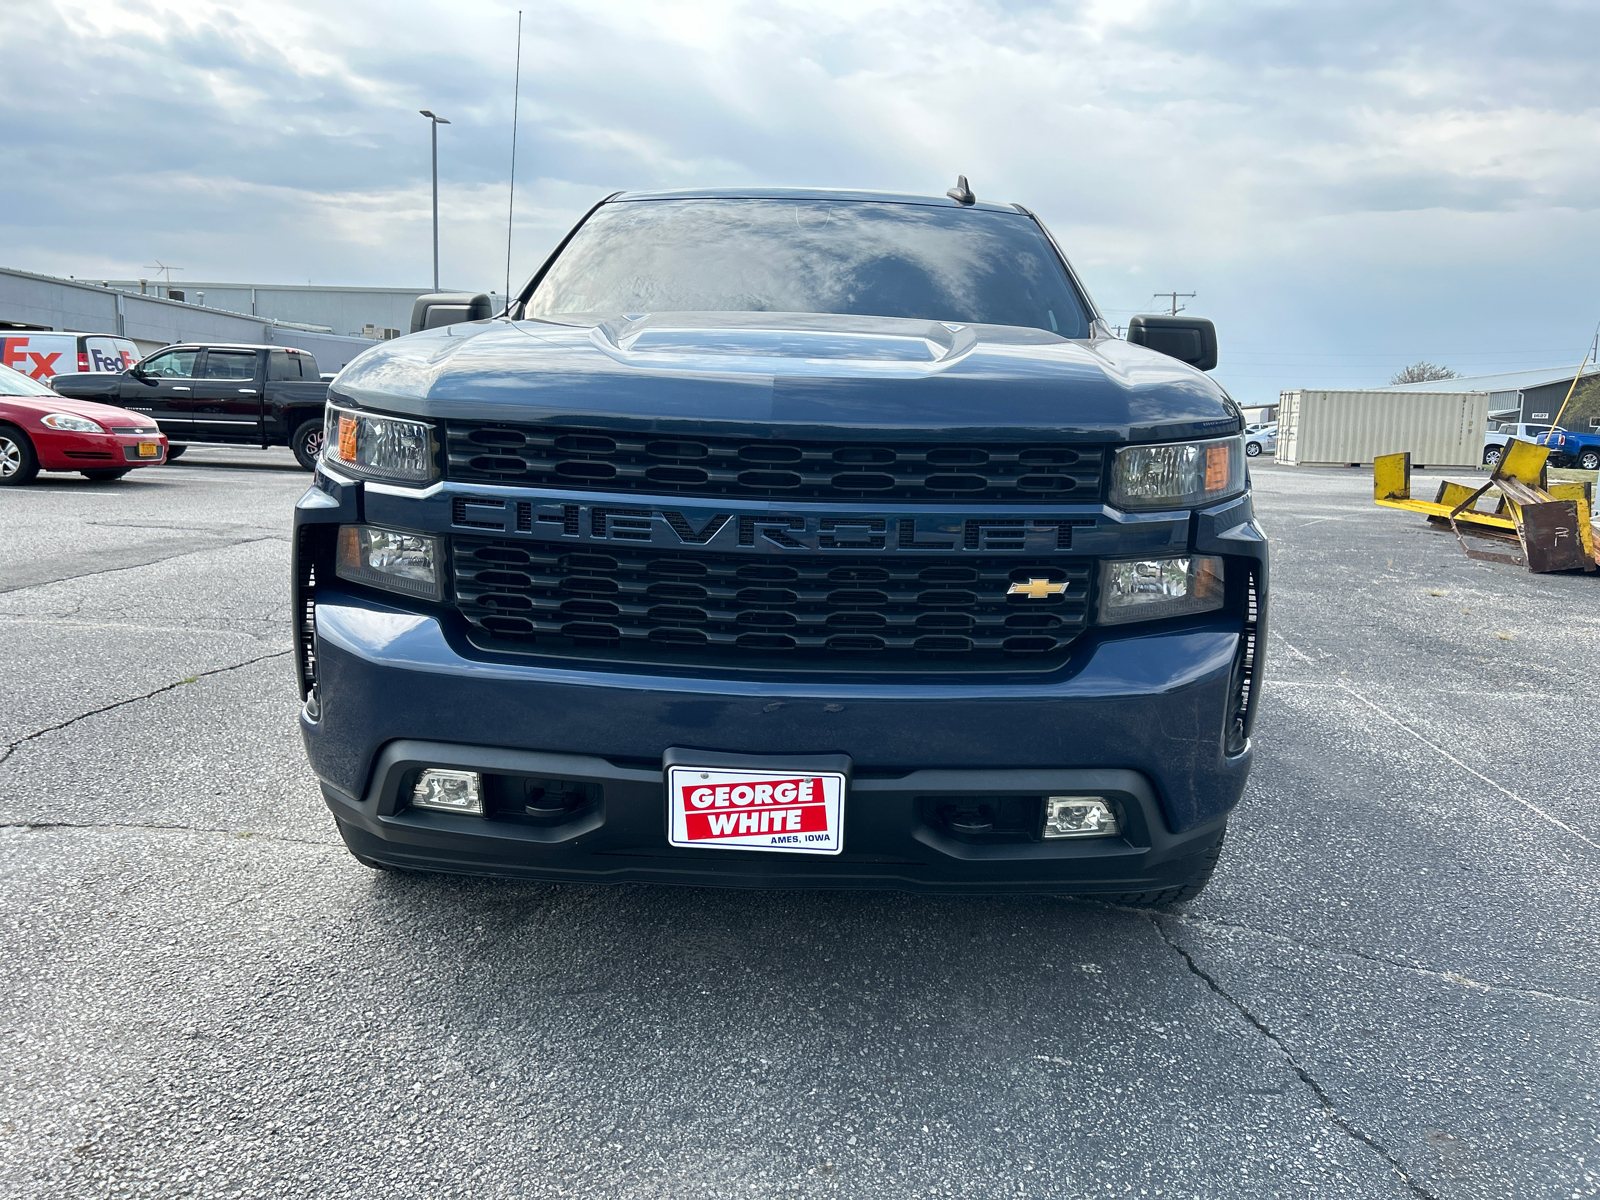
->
[[1278, 389, 1490, 467]]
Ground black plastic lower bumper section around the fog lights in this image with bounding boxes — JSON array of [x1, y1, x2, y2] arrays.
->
[[323, 741, 1226, 894]]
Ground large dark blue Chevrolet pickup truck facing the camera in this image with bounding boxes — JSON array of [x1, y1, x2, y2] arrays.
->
[[293, 181, 1267, 904]]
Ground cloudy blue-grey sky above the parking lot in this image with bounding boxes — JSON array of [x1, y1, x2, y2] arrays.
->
[[0, 0, 1600, 402]]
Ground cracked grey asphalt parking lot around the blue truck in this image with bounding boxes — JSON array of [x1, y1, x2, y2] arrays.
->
[[0, 448, 1600, 1200]]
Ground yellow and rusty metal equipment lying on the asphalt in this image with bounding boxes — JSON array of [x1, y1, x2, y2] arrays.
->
[[1373, 442, 1600, 573]]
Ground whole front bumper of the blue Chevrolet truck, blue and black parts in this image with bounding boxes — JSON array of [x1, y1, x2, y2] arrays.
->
[[296, 480, 1266, 893]]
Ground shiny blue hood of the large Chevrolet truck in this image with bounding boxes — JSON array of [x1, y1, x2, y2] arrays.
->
[[330, 312, 1243, 442]]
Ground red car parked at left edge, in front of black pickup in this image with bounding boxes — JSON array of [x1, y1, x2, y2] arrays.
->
[[0, 366, 166, 486]]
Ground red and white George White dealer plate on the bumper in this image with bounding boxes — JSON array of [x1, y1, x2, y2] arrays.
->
[[667, 766, 845, 854]]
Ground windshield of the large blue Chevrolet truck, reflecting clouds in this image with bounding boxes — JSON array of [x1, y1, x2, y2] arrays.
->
[[526, 200, 1088, 338]]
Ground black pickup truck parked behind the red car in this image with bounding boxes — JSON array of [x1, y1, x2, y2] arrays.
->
[[53, 342, 328, 470]]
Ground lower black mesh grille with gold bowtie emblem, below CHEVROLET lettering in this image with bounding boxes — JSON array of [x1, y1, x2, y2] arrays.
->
[[451, 538, 1093, 667]]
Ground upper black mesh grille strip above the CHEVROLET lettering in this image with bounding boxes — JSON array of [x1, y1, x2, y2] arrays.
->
[[445, 422, 1104, 502]]
